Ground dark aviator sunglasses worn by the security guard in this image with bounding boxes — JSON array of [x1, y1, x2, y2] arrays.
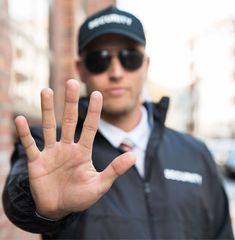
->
[[84, 48, 144, 74]]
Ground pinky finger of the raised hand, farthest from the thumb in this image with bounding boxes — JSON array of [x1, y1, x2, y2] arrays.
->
[[15, 116, 40, 162]]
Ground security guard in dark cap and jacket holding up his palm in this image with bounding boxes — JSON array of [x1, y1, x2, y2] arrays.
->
[[3, 6, 233, 239]]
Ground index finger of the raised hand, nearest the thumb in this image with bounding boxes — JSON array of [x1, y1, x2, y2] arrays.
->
[[79, 91, 103, 150]]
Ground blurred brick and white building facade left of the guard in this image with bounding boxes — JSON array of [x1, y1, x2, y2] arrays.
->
[[0, 0, 116, 240]]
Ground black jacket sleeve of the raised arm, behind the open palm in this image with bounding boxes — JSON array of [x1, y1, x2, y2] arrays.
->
[[2, 127, 74, 234]]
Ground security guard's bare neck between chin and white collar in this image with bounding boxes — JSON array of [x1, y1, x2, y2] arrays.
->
[[102, 107, 141, 132]]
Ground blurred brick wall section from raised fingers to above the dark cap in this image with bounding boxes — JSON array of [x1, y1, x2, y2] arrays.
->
[[50, 0, 116, 122]]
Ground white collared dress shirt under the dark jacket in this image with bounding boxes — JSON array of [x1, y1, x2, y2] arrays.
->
[[99, 107, 151, 177]]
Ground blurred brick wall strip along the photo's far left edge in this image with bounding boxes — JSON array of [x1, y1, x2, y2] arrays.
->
[[0, 0, 40, 240]]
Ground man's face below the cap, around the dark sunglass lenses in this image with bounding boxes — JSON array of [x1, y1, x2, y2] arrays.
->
[[78, 35, 149, 117]]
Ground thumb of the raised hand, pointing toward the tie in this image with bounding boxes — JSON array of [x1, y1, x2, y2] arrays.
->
[[100, 152, 136, 193]]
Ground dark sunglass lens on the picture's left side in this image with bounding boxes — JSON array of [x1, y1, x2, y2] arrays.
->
[[85, 50, 111, 73]]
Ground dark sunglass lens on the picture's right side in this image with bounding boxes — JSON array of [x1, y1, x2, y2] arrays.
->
[[119, 49, 144, 71]]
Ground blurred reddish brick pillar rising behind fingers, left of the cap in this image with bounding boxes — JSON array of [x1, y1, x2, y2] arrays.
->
[[49, 0, 76, 122]]
